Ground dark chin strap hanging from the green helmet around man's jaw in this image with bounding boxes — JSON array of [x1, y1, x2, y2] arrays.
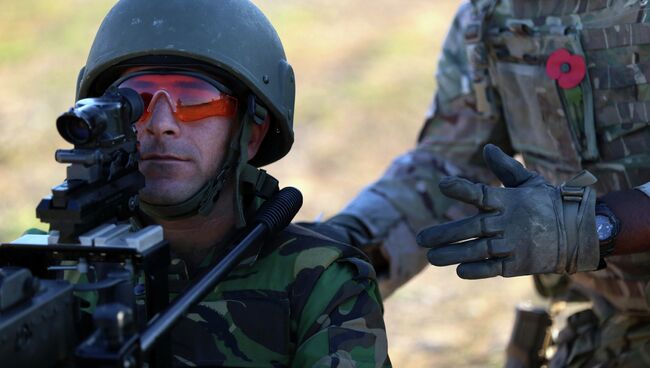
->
[[140, 95, 278, 224]]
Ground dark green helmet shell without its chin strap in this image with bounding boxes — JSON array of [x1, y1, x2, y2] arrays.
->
[[76, 0, 295, 166]]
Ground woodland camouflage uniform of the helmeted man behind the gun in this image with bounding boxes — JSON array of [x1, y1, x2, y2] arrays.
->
[[67, 225, 391, 367]]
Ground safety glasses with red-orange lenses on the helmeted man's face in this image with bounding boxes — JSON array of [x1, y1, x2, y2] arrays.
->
[[114, 71, 237, 123]]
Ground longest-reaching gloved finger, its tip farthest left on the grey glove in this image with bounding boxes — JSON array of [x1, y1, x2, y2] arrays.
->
[[417, 214, 483, 248]]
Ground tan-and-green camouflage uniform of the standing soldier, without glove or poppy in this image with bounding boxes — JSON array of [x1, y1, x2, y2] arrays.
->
[[333, 0, 650, 367]]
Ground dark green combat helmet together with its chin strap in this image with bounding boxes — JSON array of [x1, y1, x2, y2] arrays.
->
[[76, 0, 295, 227]]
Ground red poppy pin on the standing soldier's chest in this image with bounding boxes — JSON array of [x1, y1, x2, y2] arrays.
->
[[546, 49, 587, 89]]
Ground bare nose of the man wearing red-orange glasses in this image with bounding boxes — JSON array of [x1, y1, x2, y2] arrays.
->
[[138, 90, 180, 137]]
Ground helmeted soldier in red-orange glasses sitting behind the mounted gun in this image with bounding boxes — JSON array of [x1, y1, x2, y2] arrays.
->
[[69, 0, 390, 367]]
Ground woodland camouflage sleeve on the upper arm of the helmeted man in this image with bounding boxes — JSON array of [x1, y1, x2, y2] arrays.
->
[[291, 258, 390, 368]]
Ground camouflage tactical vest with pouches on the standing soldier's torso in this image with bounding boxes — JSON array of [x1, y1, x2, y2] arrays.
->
[[465, 0, 650, 314]]
